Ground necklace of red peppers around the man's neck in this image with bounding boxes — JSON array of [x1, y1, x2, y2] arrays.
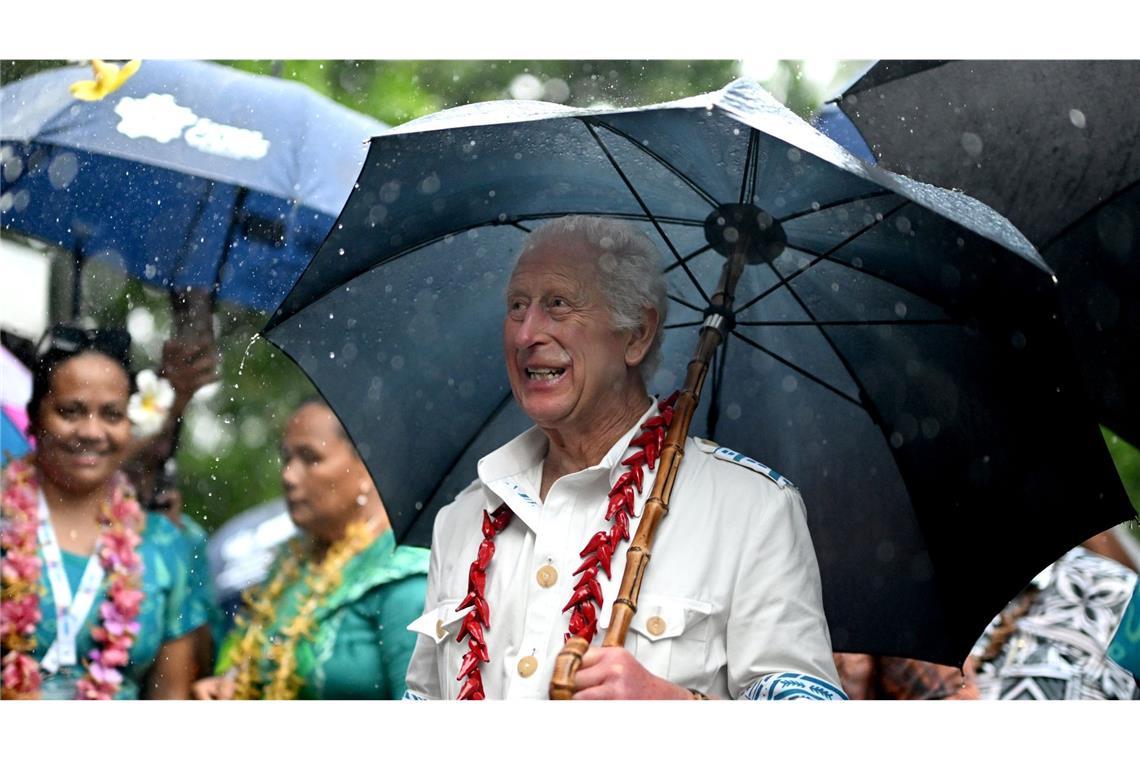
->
[[456, 391, 681, 700]]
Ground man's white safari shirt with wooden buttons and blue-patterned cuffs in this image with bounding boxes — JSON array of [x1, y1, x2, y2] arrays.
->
[[406, 404, 845, 698]]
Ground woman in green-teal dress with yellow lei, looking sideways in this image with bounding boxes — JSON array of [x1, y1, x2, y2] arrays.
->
[[194, 401, 429, 700]]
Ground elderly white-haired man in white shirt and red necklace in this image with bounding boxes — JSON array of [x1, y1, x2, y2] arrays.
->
[[406, 216, 845, 700]]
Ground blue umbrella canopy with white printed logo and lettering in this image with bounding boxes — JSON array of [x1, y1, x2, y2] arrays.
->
[[0, 60, 385, 312]]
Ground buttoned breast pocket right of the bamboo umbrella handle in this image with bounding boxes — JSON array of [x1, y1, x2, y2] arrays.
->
[[626, 594, 713, 685]]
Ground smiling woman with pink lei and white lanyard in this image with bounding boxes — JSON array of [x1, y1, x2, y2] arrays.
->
[[0, 325, 206, 700]]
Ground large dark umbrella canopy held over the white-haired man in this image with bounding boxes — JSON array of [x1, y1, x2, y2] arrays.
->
[[264, 81, 1132, 662]]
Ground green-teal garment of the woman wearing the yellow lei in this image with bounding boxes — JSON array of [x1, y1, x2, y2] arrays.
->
[[218, 530, 430, 700]]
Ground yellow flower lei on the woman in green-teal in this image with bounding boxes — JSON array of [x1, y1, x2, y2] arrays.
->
[[234, 521, 374, 700]]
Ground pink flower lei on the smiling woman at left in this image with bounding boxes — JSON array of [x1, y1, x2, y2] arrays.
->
[[0, 458, 144, 700]]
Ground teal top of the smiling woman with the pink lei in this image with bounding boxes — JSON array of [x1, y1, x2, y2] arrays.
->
[[32, 513, 206, 700]]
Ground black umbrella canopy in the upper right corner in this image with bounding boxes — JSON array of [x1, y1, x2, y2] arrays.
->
[[823, 60, 1140, 444]]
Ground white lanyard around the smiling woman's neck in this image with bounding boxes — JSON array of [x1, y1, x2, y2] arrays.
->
[[36, 490, 104, 673]]
